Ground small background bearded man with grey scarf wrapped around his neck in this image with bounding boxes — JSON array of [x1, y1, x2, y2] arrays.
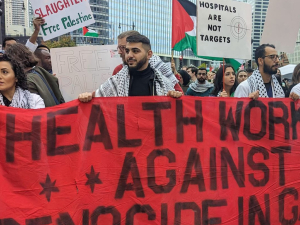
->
[[185, 68, 214, 97]]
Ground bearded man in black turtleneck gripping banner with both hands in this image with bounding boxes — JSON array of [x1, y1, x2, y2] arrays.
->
[[78, 34, 182, 102]]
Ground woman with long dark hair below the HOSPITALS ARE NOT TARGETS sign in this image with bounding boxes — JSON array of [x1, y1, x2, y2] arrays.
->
[[212, 64, 238, 97]]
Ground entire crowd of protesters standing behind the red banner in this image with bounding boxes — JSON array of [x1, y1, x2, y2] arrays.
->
[[0, 24, 300, 109]]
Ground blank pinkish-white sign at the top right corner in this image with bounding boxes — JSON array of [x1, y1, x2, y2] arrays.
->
[[260, 0, 300, 53]]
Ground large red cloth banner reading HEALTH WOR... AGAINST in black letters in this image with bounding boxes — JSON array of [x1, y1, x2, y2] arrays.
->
[[0, 97, 300, 225]]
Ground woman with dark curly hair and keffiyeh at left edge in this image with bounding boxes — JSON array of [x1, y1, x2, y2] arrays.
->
[[0, 54, 45, 109]]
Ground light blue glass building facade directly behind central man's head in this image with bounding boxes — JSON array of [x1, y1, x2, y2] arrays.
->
[[109, 0, 201, 66]]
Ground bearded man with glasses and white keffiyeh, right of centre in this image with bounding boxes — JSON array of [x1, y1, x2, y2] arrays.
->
[[234, 44, 285, 99]]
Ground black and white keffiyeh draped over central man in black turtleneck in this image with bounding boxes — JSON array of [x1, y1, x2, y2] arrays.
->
[[95, 64, 174, 97]]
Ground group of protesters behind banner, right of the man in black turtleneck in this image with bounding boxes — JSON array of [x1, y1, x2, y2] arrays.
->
[[172, 44, 300, 100]]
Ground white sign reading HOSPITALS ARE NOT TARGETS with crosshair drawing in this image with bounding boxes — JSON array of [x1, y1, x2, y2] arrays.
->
[[197, 0, 252, 59]]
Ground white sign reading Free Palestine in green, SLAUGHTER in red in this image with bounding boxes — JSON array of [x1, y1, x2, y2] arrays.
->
[[30, 0, 95, 41]]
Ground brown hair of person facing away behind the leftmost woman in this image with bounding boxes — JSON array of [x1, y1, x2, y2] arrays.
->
[[5, 43, 38, 69]]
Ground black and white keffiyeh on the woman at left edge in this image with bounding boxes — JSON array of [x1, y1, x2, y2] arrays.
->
[[0, 87, 34, 109]]
